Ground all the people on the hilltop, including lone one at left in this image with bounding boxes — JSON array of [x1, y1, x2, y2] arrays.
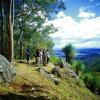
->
[[26, 46, 50, 65]]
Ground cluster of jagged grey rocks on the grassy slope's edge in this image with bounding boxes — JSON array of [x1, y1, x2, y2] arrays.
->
[[38, 60, 79, 84]]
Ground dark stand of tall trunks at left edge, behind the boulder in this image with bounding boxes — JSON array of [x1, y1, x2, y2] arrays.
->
[[0, 0, 14, 62]]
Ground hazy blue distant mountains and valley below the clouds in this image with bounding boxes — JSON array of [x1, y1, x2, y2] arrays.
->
[[54, 48, 100, 72]]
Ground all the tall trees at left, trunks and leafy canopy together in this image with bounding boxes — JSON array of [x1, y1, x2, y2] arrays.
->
[[0, 0, 65, 61]]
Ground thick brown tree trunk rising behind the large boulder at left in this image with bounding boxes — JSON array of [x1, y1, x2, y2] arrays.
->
[[6, 0, 13, 62]]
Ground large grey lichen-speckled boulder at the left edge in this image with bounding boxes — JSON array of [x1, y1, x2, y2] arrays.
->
[[0, 55, 16, 84]]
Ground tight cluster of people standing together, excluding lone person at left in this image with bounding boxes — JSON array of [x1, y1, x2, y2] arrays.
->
[[34, 49, 50, 65]]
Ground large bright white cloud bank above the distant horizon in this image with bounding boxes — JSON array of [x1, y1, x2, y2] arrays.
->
[[49, 13, 100, 48]]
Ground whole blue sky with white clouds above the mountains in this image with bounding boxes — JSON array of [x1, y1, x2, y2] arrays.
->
[[49, 0, 100, 48]]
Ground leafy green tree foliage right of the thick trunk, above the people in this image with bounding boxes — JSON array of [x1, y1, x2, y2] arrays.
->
[[14, 0, 65, 58]]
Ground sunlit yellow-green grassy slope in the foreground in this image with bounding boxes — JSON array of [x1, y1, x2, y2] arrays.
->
[[0, 62, 100, 100]]
